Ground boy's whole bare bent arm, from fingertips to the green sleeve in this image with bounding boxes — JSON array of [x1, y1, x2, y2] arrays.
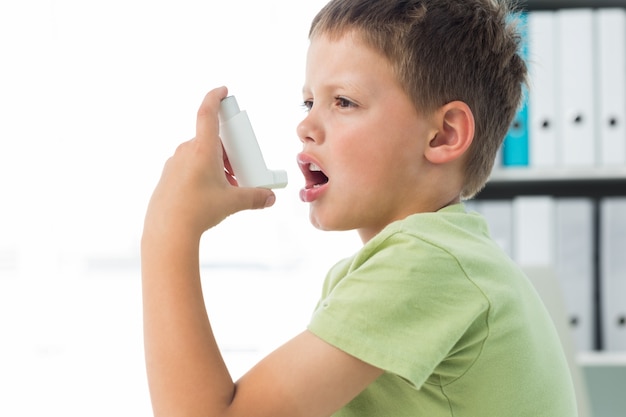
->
[[142, 88, 382, 417]]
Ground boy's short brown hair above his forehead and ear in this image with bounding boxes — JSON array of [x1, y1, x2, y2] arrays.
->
[[309, 0, 527, 198]]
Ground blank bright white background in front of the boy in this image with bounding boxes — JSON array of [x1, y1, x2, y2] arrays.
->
[[0, 0, 357, 417]]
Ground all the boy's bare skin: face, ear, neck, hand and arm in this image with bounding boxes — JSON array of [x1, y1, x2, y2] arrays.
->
[[141, 30, 473, 417]]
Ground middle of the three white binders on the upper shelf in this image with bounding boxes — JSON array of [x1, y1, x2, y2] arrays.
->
[[555, 8, 596, 167]]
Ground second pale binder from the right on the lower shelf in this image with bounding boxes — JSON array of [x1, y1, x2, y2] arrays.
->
[[555, 198, 596, 351]]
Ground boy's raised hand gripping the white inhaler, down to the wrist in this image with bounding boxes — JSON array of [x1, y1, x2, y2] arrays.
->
[[145, 87, 275, 238]]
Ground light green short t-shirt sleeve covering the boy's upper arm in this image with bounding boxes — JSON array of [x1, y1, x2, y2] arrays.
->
[[309, 229, 488, 388]]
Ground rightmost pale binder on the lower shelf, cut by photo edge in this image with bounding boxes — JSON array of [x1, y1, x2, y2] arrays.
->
[[600, 197, 626, 351]]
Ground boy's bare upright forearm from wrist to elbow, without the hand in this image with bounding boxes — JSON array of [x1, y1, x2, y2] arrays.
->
[[142, 232, 234, 416]]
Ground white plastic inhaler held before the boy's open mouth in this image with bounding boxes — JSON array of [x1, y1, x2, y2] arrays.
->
[[219, 96, 287, 188]]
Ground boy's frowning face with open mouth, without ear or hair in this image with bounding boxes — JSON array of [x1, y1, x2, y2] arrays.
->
[[298, 33, 435, 242]]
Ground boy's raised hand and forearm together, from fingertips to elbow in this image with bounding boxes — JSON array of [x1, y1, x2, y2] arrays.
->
[[141, 88, 275, 417]]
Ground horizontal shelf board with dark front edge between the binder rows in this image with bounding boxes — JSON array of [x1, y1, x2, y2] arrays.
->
[[476, 167, 626, 199]]
